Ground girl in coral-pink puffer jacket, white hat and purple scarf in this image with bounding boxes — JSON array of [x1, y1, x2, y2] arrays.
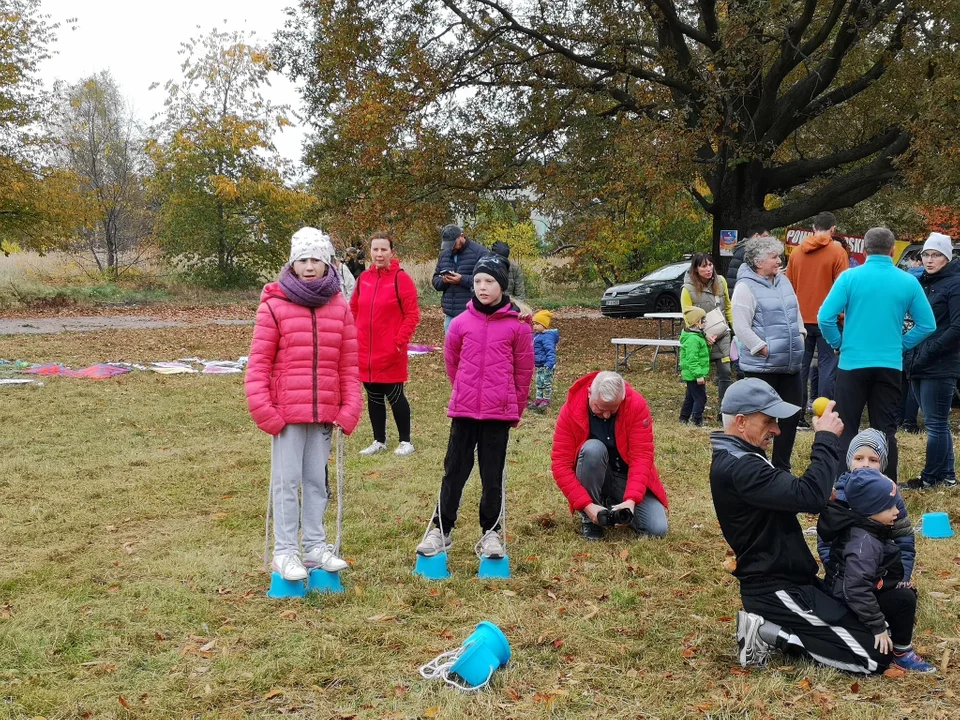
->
[[244, 228, 361, 580]]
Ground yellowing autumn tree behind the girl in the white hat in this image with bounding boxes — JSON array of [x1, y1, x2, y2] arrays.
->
[[149, 30, 312, 285]]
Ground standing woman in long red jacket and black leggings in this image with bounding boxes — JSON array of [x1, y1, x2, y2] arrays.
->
[[350, 233, 420, 455]]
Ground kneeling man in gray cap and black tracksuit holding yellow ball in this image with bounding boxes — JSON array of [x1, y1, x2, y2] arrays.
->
[[710, 378, 890, 673]]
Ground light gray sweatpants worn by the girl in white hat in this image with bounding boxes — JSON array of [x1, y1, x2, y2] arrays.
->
[[270, 423, 333, 555]]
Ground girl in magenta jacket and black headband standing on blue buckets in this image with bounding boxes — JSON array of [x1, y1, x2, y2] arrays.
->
[[417, 255, 533, 558]]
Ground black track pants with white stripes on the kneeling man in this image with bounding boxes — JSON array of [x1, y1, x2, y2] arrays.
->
[[741, 581, 892, 673]]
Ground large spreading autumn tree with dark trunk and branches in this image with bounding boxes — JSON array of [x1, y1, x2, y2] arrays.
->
[[276, 0, 957, 252]]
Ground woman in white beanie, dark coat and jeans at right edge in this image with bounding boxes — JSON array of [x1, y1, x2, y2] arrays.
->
[[906, 233, 960, 490]]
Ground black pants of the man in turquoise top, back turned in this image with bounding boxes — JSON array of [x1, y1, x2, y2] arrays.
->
[[834, 368, 901, 482]]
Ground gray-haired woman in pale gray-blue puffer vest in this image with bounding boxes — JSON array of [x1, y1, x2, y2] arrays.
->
[[731, 237, 806, 472]]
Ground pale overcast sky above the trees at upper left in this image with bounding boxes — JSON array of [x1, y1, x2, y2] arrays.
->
[[41, 0, 303, 162]]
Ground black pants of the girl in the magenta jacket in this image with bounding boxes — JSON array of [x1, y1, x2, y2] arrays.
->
[[433, 418, 510, 533]]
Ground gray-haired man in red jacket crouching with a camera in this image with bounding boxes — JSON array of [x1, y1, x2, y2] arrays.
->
[[552, 371, 667, 540]]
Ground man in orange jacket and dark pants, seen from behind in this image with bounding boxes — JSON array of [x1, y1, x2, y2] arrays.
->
[[787, 212, 849, 416]]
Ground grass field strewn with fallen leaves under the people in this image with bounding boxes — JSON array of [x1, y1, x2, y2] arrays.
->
[[0, 306, 960, 720]]
